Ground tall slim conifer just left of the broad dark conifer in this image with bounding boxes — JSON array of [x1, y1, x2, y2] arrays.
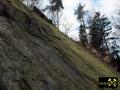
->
[[74, 4, 87, 46]]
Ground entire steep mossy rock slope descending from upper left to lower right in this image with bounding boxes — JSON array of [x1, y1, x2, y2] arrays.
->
[[0, 0, 120, 90]]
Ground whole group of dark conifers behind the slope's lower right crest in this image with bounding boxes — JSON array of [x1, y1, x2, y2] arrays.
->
[[74, 4, 120, 71]]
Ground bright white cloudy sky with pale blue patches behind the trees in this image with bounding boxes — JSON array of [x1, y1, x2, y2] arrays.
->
[[61, 0, 119, 40]]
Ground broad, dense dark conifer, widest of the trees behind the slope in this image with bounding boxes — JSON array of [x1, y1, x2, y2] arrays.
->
[[90, 12, 112, 54]]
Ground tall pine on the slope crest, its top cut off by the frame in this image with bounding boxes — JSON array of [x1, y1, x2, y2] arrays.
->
[[47, 0, 64, 28]]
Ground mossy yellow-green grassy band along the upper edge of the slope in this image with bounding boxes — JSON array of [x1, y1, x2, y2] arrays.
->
[[1, 0, 120, 90]]
